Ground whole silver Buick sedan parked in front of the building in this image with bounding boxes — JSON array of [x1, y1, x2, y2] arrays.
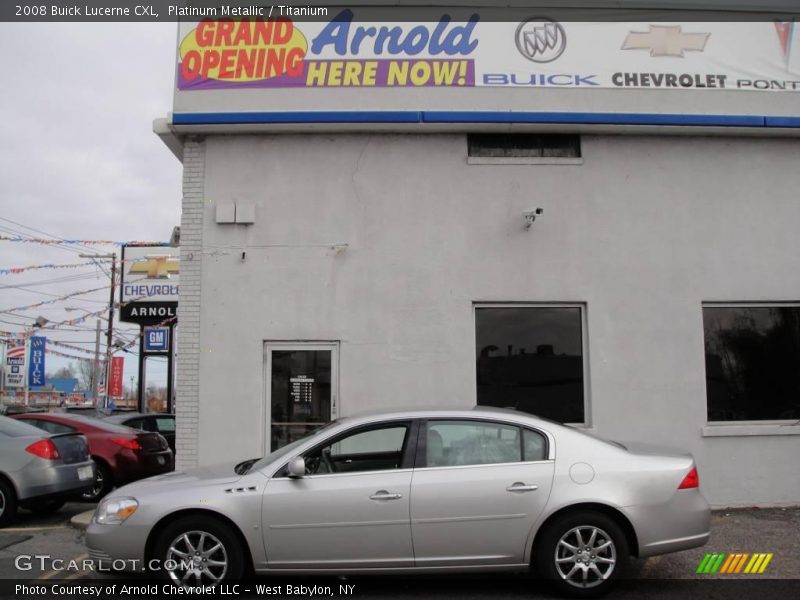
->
[[86, 409, 710, 594]]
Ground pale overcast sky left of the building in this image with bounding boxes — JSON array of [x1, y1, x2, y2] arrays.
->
[[0, 23, 181, 398]]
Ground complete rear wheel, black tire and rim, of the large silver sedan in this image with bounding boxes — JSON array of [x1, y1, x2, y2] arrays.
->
[[535, 511, 630, 598]]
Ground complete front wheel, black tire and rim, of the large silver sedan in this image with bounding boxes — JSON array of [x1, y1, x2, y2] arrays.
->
[[153, 516, 245, 586]]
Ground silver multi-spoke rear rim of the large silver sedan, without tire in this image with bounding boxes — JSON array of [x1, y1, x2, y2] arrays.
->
[[554, 525, 617, 588]]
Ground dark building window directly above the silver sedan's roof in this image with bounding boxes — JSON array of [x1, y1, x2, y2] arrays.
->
[[475, 306, 585, 423]]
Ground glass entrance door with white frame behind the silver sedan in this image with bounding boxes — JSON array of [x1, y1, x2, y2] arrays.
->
[[265, 342, 339, 452]]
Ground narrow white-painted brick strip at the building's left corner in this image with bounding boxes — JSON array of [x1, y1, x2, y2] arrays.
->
[[175, 138, 205, 469]]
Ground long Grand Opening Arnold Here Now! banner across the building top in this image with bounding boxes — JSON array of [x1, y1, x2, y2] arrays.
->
[[177, 14, 800, 95]]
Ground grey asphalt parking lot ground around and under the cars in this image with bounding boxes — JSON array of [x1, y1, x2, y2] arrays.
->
[[0, 503, 800, 600]]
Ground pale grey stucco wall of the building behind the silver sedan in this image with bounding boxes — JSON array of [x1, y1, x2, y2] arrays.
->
[[172, 132, 800, 505]]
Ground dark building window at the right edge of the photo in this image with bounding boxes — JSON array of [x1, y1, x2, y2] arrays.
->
[[703, 306, 800, 421]]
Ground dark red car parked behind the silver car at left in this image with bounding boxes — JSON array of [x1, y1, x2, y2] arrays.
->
[[12, 413, 175, 502]]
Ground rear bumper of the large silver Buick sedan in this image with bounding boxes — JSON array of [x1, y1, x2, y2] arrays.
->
[[625, 489, 711, 558]]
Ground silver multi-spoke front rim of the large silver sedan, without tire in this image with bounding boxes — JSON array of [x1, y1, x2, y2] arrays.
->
[[164, 531, 228, 586]]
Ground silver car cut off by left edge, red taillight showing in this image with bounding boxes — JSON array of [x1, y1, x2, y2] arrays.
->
[[0, 416, 94, 527]]
